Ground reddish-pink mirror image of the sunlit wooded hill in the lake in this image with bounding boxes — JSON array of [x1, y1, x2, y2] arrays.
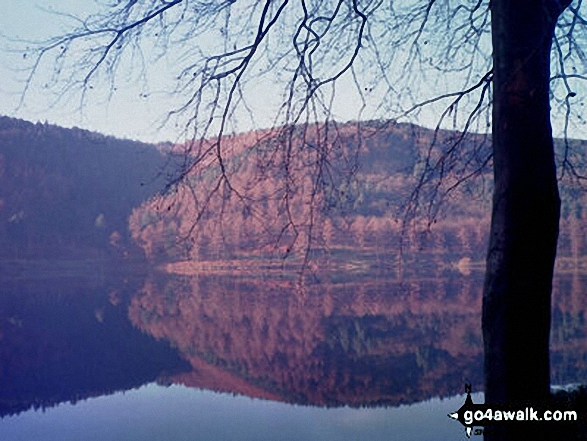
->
[[129, 276, 587, 405]]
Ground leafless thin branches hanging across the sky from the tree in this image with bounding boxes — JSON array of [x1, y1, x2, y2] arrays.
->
[[13, 0, 587, 257]]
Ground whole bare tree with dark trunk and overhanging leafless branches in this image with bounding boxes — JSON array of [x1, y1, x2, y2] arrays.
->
[[12, 0, 587, 437]]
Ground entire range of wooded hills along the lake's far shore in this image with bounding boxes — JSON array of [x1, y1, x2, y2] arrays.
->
[[0, 117, 587, 272]]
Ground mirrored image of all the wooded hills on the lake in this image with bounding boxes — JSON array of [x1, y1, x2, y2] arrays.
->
[[0, 266, 587, 439]]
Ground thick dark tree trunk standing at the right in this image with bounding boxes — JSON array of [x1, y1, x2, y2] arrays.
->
[[483, 0, 569, 440]]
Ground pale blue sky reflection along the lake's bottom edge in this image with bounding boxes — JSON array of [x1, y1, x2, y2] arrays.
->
[[0, 384, 482, 441]]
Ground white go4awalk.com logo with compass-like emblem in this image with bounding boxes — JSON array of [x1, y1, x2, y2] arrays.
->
[[448, 384, 578, 438]]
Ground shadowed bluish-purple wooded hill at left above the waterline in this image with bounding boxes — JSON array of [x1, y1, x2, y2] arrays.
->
[[0, 117, 165, 260]]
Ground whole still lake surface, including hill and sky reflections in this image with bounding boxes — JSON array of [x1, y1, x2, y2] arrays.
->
[[0, 262, 587, 440]]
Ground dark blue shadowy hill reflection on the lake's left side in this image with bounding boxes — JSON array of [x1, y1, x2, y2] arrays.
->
[[0, 270, 186, 417]]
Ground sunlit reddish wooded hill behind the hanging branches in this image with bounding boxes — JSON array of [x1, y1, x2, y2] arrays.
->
[[131, 118, 587, 271]]
